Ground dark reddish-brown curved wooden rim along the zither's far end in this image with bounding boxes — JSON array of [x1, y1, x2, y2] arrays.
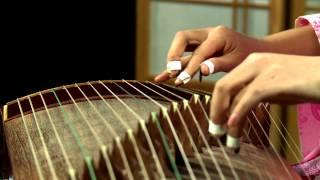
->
[[3, 80, 210, 122]]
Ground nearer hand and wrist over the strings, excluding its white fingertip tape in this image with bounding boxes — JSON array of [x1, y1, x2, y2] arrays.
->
[[210, 53, 320, 141]]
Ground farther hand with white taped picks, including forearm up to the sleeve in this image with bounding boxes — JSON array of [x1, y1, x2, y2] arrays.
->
[[154, 26, 320, 85]]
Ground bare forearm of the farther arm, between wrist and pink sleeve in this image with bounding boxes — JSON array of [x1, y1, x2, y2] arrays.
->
[[262, 26, 320, 56]]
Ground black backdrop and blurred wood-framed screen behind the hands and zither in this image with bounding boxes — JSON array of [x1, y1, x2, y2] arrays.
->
[[0, 0, 320, 166]]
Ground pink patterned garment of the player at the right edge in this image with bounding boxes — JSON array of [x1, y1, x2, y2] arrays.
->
[[293, 14, 320, 177]]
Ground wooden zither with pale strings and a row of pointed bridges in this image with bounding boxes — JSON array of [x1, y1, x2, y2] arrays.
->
[[2, 80, 299, 180]]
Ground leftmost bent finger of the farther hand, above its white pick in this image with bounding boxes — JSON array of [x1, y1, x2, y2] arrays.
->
[[167, 29, 208, 61]]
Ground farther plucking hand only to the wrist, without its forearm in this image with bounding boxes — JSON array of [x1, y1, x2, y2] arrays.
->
[[155, 26, 266, 85]]
